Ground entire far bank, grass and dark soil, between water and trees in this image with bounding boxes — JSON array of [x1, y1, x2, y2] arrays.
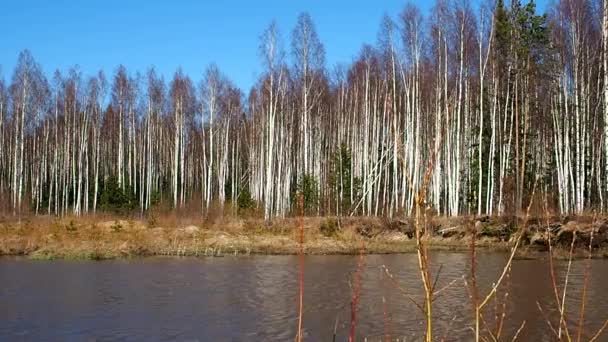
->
[[0, 216, 608, 259]]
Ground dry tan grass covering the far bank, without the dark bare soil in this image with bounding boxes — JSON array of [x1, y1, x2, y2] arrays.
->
[[0, 212, 608, 259]]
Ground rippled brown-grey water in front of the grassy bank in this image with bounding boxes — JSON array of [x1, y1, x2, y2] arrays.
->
[[0, 253, 608, 341]]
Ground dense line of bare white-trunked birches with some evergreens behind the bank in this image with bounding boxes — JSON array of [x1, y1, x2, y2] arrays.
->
[[0, 0, 608, 218]]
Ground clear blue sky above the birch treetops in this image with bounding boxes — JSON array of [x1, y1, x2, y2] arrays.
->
[[0, 0, 548, 93]]
